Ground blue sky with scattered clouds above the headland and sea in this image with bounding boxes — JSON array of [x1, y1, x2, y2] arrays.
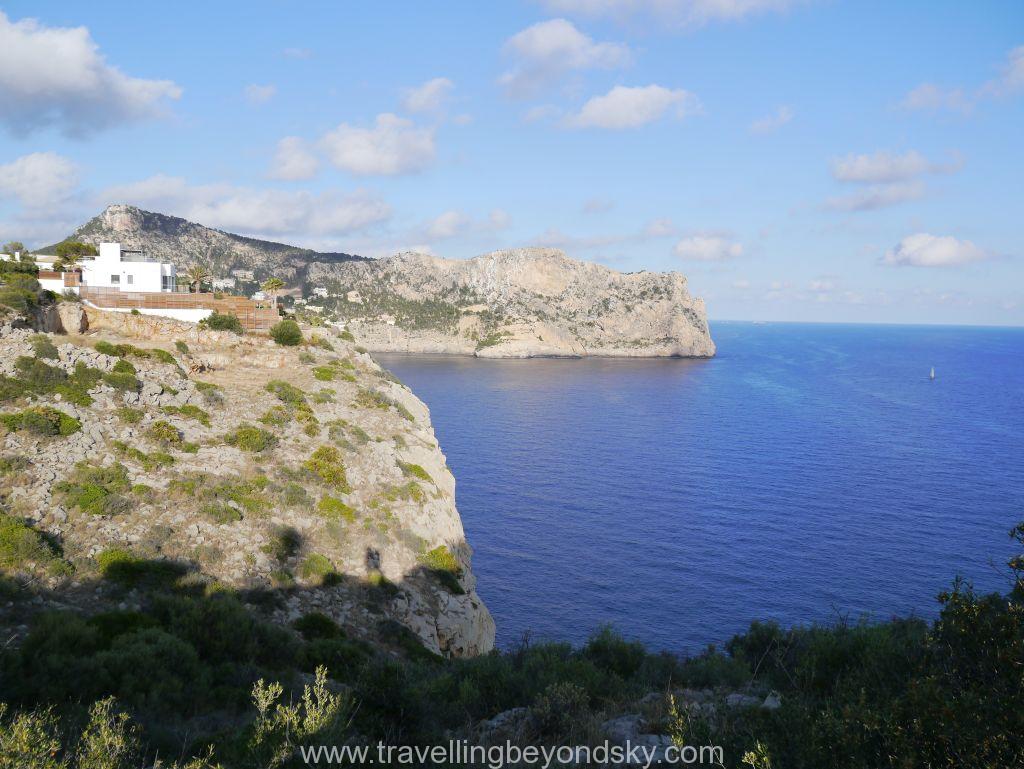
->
[[0, 0, 1024, 325]]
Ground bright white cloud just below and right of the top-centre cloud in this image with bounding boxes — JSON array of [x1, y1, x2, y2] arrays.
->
[[564, 85, 701, 130]]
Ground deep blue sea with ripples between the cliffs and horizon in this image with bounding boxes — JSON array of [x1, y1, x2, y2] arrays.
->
[[378, 323, 1024, 652]]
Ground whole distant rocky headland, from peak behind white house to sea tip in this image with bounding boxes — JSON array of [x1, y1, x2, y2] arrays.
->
[[51, 205, 715, 357]]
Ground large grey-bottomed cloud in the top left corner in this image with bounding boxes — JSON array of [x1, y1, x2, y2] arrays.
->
[[0, 11, 181, 137]]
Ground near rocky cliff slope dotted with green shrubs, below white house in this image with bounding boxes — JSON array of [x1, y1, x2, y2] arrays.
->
[[0, 310, 495, 656]]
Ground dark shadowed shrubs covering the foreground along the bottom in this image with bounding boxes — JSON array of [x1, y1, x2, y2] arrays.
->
[[0, 517, 1024, 769]]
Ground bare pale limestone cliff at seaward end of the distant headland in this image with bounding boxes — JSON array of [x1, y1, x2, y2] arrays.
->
[[307, 248, 715, 357]]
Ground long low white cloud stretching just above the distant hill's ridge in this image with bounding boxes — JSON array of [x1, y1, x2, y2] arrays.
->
[[101, 175, 391, 238]]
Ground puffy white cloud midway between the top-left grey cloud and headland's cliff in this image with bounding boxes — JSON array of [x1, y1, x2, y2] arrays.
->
[[319, 113, 435, 176]]
